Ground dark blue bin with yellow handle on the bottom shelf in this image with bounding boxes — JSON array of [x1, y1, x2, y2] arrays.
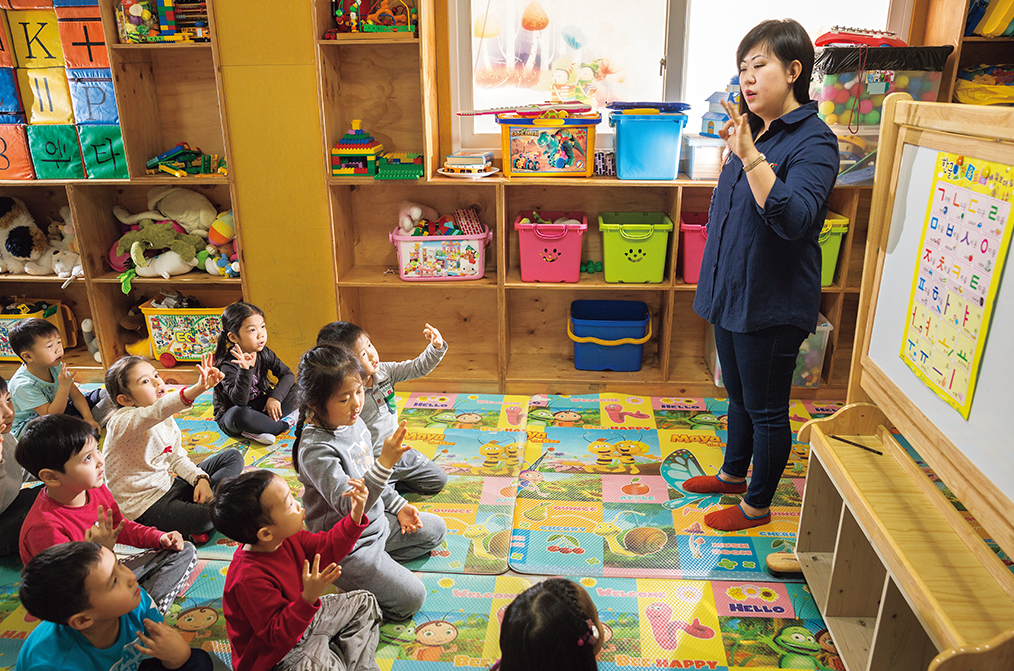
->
[[567, 301, 651, 371]]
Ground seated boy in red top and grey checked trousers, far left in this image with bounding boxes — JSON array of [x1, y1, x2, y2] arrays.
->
[[14, 415, 197, 612]]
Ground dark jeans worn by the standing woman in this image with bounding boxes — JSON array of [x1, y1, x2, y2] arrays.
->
[[715, 324, 807, 508]]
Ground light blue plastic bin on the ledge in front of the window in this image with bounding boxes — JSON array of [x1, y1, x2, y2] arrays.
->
[[609, 110, 686, 179]]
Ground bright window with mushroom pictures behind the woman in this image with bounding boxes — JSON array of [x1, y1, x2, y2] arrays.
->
[[450, 0, 896, 148]]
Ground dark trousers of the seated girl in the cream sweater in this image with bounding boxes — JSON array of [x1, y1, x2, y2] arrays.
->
[[137, 449, 243, 538]]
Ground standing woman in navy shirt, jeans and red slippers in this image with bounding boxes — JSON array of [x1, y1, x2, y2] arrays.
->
[[683, 19, 838, 531]]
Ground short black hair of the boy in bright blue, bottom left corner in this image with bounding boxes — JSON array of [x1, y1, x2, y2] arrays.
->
[[17, 540, 102, 624]]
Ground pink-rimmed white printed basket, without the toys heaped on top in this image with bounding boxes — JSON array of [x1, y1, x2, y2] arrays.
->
[[388, 224, 493, 282]]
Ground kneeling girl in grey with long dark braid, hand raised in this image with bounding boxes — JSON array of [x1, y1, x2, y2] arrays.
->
[[292, 346, 446, 620]]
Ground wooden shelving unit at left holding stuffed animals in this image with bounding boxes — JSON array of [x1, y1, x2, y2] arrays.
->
[[0, 0, 244, 382]]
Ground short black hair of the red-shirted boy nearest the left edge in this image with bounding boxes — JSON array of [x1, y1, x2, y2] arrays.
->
[[14, 415, 98, 477]]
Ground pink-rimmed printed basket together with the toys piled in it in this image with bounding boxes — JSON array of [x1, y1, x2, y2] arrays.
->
[[389, 208, 493, 282]]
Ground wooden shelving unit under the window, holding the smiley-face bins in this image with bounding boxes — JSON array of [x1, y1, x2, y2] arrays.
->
[[314, 0, 871, 397]]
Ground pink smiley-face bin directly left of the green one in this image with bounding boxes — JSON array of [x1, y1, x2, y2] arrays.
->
[[514, 210, 588, 282]]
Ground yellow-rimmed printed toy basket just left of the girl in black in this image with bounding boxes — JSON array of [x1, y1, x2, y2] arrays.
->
[[141, 299, 225, 367]]
